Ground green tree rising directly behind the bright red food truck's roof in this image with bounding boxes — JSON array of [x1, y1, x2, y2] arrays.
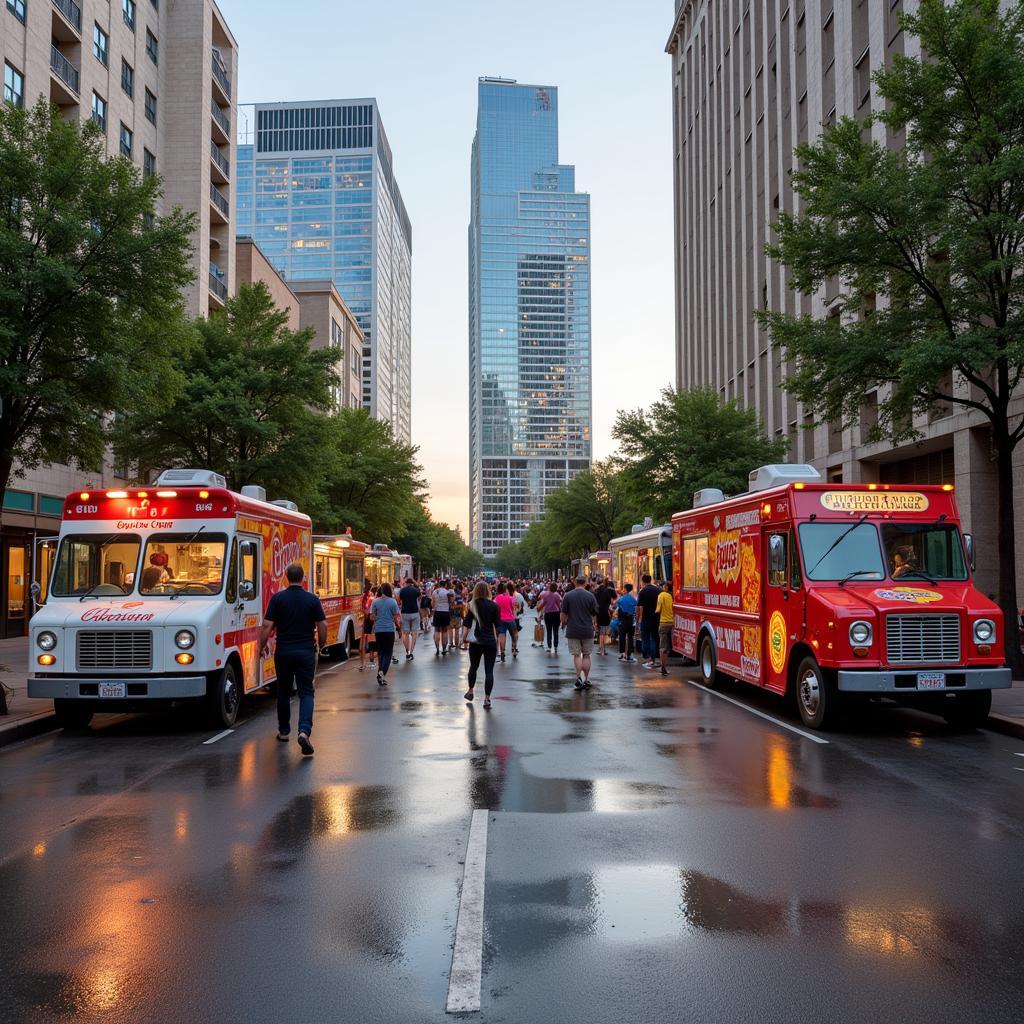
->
[[611, 387, 788, 522]]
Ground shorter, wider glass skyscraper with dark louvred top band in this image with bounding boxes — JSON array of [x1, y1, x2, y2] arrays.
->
[[236, 99, 413, 443]]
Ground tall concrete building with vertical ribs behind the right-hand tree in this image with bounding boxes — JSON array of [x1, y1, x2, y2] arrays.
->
[[667, 0, 1024, 593]]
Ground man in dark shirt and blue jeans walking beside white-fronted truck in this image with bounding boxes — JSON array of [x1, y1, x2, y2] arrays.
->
[[259, 562, 327, 757]]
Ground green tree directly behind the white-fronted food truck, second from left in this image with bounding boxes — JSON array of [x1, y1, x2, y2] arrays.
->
[[115, 283, 339, 504]]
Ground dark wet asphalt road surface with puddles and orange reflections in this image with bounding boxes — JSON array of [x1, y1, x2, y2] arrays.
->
[[0, 641, 1024, 1024]]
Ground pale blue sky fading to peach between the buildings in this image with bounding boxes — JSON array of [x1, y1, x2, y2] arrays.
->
[[218, 0, 675, 536]]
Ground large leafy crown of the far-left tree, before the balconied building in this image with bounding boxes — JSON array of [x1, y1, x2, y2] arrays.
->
[[0, 99, 195, 492]]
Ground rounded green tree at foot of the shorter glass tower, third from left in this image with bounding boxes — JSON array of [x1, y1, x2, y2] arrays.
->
[[310, 409, 423, 540]]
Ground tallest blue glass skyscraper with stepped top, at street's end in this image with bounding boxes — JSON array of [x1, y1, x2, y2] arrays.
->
[[469, 78, 591, 555]]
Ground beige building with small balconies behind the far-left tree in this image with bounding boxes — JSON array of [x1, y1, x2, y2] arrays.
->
[[0, 0, 238, 637]]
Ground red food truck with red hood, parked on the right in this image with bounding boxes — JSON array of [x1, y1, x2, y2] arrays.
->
[[672, 465, 1011, 728]]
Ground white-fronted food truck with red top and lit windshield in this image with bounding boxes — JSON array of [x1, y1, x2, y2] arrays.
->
[[28, 469, 312, 727]]
